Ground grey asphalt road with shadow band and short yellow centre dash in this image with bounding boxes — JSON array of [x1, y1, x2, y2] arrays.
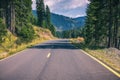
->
[[0, 40, 120, 80]]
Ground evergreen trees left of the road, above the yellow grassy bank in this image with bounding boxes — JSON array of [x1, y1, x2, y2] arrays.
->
[[0, 0, 55, 42]]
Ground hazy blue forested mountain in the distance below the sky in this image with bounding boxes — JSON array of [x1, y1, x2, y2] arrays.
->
[[33, 11, 86, 31]]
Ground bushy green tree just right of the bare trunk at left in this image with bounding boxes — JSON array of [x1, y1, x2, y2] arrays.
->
[[15, 0, 34, 42]]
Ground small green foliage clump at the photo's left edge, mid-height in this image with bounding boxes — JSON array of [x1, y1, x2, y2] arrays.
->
[[0, 18, 7, 43]]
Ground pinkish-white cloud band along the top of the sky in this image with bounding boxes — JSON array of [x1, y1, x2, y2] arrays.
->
[[45, 0, 89, 11]]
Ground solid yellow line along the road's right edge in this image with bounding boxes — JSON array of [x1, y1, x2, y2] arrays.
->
[[81, 50, 120, 78]]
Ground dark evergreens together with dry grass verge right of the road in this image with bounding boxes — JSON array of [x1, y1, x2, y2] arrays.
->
[[71, 0, 120, 73]]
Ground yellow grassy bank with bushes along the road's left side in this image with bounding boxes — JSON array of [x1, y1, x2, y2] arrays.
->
[[0, 26, 55, 59]]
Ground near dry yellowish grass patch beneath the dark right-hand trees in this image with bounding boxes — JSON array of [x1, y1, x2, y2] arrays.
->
[[85, 48, 120, 73]]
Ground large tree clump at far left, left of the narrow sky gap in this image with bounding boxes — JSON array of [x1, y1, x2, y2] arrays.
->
[[0, 0, 34, 42]]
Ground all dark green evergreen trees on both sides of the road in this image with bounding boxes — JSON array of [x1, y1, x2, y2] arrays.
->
[[0, 0, 120, 49]]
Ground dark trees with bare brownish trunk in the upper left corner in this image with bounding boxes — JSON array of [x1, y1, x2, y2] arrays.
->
[[0, 0, 15, 33]]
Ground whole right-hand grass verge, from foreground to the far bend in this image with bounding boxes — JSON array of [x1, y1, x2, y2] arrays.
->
[[72, 38, 120, 74]]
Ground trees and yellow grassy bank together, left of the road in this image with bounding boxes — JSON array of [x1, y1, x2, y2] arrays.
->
[[0, 0, 56, 59]]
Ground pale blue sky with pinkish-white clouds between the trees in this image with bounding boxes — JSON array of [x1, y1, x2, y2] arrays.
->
[[32, 0, 90, 18]]
